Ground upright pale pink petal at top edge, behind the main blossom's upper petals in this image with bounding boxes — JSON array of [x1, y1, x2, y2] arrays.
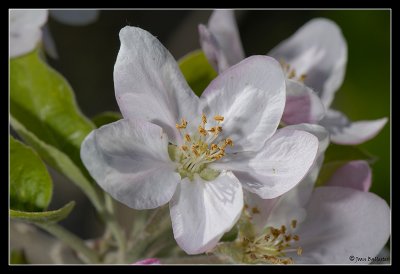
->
[[199, 10, 244, 73]]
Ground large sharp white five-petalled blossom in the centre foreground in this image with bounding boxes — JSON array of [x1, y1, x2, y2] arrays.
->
[[81, 27, 318, 254]]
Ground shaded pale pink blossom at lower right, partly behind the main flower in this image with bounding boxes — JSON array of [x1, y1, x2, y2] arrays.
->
[[215, 124, 390, 264]]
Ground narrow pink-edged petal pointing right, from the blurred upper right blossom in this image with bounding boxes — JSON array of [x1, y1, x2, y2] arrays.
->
[[319, 109, 388, 145]]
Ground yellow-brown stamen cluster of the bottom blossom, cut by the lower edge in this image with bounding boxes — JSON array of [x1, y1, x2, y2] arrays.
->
[[242, 220, 303, 264]]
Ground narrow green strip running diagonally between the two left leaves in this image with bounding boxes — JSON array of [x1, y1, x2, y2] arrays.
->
[[10, 115, 103, 210]]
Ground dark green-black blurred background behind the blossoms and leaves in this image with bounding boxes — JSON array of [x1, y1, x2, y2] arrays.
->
[[44, 10, 391, 238]]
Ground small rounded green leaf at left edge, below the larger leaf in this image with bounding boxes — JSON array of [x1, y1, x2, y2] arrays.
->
[[10, 136, 53, 211]]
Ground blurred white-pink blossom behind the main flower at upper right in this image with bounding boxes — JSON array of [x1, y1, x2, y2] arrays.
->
[[199, 10, 387, 144]]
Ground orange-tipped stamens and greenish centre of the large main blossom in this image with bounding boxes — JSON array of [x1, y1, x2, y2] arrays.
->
[[170, 114, 233, 180]]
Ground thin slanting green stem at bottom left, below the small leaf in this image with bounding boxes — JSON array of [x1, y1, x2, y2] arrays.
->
[[37, 224, 100, 263]]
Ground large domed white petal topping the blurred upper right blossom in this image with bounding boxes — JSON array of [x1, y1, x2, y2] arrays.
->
[[268, 18, 347, 107]]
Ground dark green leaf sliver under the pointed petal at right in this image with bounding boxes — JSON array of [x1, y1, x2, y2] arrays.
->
[[324, 144, 376, 163]]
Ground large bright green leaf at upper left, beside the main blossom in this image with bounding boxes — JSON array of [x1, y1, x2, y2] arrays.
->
[[10, 50, 94, 169]]
